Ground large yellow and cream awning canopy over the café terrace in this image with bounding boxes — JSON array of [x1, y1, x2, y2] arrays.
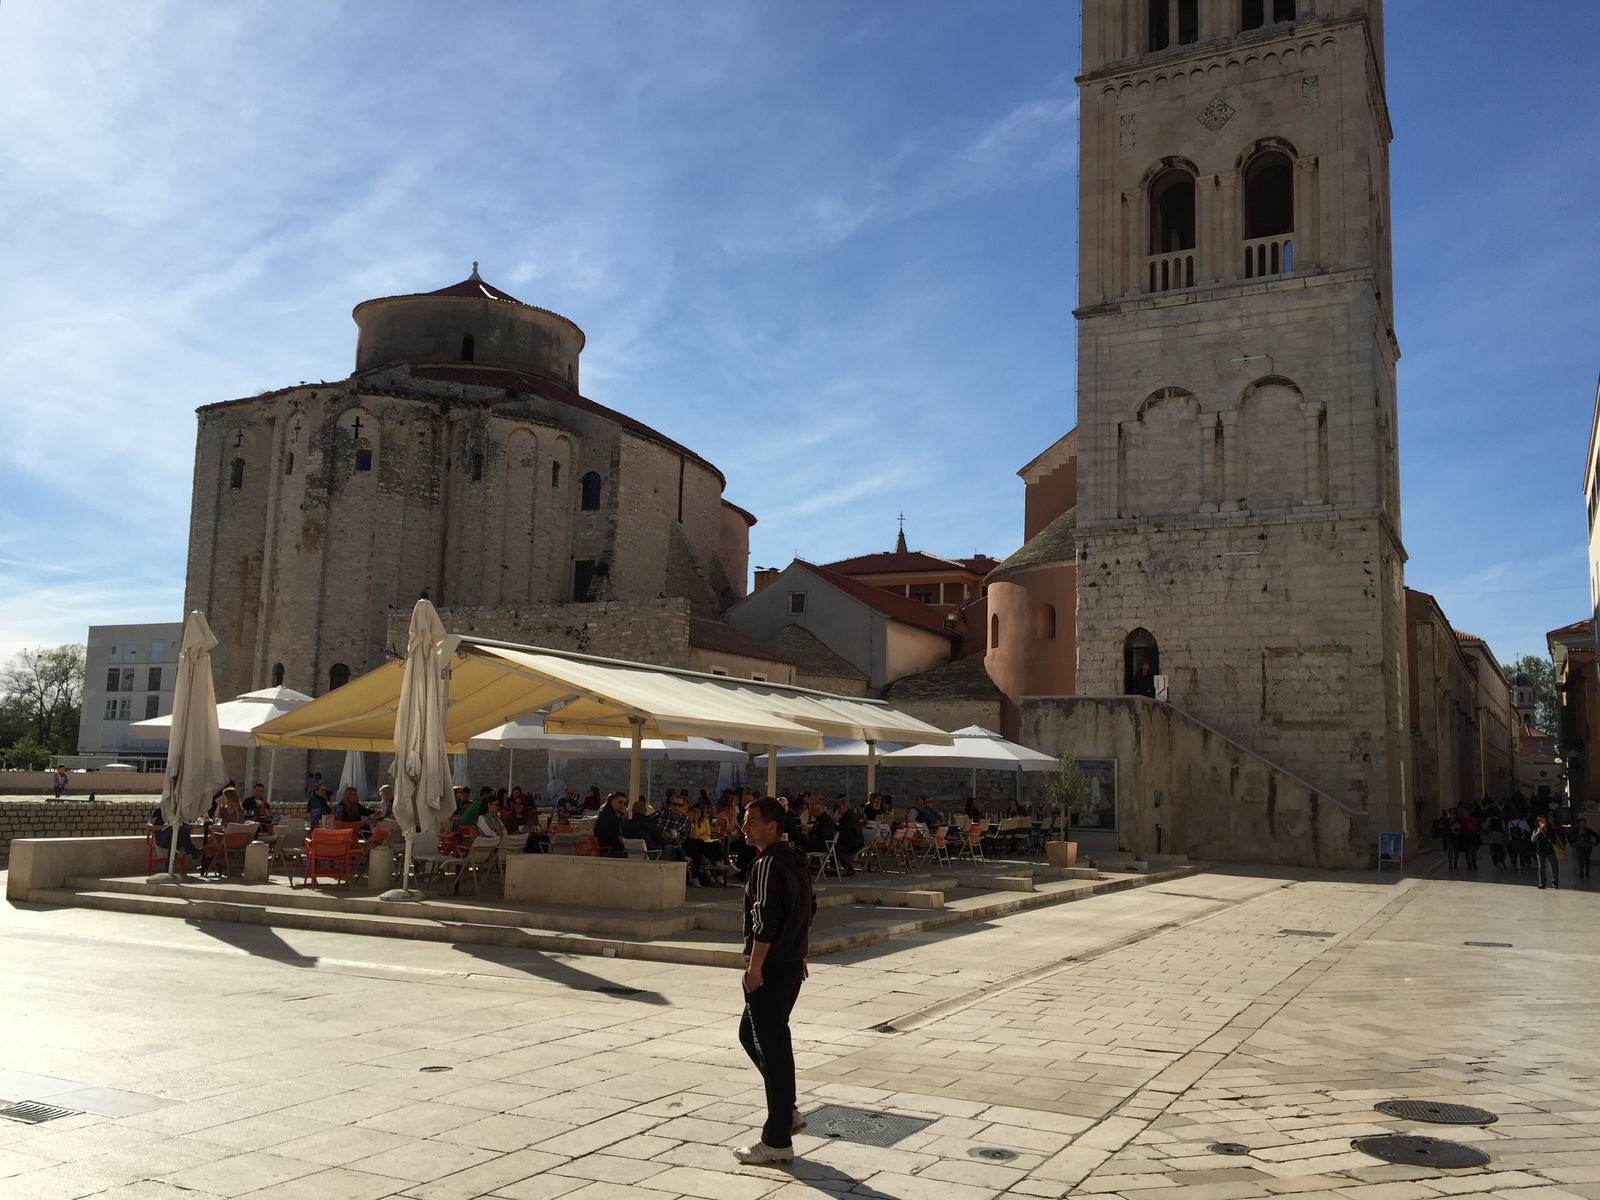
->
[[256, 638, 950, 754]]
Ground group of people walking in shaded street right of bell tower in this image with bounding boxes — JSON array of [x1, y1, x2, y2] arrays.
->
[[1432, 797, 1600, 888]]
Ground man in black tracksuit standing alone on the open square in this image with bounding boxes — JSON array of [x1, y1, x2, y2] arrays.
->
[[733, 797, 816, 1165]]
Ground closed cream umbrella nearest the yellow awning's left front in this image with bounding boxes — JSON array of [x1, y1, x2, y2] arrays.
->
[[381, 600, 456, 899]]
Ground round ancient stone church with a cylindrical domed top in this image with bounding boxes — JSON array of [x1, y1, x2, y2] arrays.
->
[[184, 264, 755, 710]]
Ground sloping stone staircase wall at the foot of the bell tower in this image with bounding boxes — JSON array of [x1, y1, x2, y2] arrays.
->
[[1022, 696, 1363, 867]]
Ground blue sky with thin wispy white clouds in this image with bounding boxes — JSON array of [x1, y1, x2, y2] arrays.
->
[[0, 0, 1600, 661]]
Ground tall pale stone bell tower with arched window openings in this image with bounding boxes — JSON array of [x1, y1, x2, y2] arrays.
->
[[1075, 0, 1416, 834]]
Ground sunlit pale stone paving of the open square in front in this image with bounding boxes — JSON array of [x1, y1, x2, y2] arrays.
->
[[0, 867, 1600, 1200]]
